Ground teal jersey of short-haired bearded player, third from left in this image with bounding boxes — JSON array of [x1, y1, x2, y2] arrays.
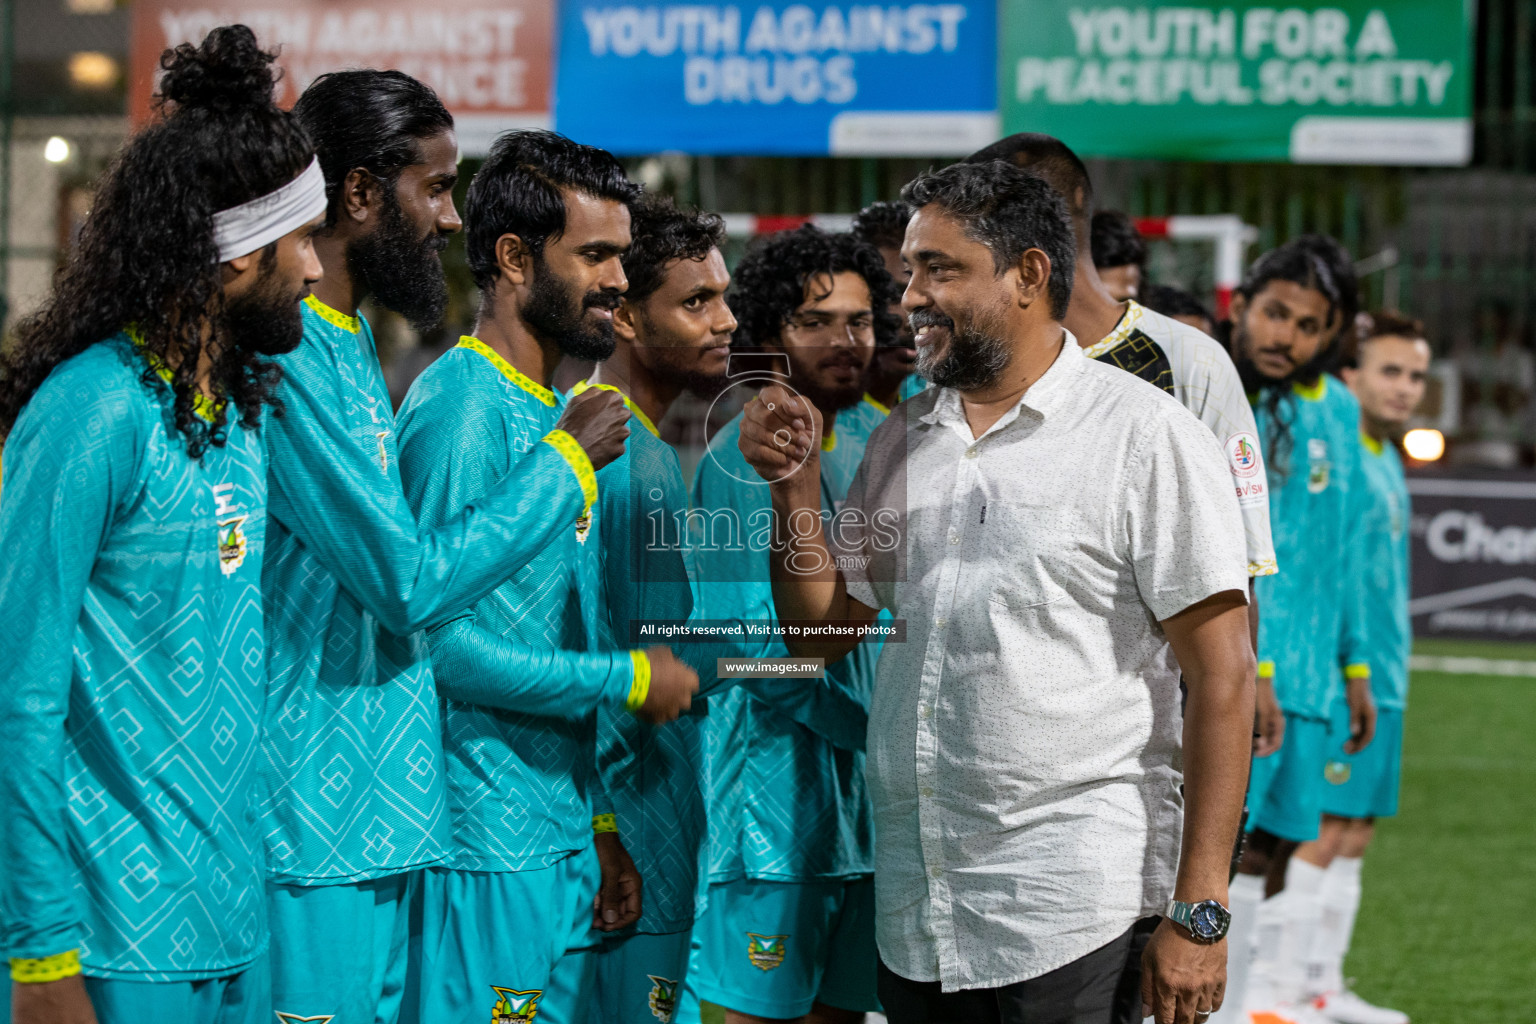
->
[[399, 338, 634, 870]]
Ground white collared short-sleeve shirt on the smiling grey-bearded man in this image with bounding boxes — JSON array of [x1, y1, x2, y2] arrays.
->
[[833, 332, 1247, 990]]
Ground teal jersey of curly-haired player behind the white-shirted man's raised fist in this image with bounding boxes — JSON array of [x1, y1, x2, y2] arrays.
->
[[693, 416, 880, 883]]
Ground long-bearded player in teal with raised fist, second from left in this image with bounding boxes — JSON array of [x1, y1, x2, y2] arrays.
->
[[263, 71, 627, 1022]]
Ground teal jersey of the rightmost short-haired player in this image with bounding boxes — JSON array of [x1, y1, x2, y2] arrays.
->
[[1356, 436, 1413, 711]]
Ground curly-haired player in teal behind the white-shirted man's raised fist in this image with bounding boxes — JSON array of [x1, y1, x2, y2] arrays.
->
[[690, 226, 899, 1022]]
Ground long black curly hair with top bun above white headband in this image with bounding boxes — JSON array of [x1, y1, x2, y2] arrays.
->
[[0, 25, 313, 457]]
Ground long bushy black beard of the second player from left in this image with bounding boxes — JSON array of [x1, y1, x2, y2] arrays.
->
[[347, 189, 449, 332]]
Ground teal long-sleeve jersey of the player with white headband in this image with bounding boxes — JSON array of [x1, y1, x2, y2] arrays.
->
[[0, 335, 270, 981]]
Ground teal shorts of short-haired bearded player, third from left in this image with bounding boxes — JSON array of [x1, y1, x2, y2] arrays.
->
[[414, 846, 599, 1024]]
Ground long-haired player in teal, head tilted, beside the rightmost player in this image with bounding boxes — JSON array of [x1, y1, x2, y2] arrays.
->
[[1229, 238, 1375, 1016]]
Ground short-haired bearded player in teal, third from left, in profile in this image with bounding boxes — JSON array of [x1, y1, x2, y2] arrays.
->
[[390, 132, 699, 1024]]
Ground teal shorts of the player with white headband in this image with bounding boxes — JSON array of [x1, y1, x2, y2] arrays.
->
[[80, 953, 272, 1024]]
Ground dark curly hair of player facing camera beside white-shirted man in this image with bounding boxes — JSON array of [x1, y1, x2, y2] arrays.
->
[[727, 224, 902, 350]]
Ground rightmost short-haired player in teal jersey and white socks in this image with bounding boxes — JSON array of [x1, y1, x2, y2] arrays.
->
[[1296, 313, 1430, 1024]]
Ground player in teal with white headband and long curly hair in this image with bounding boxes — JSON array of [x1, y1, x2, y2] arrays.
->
[[0, 25, 326, 1024]]
